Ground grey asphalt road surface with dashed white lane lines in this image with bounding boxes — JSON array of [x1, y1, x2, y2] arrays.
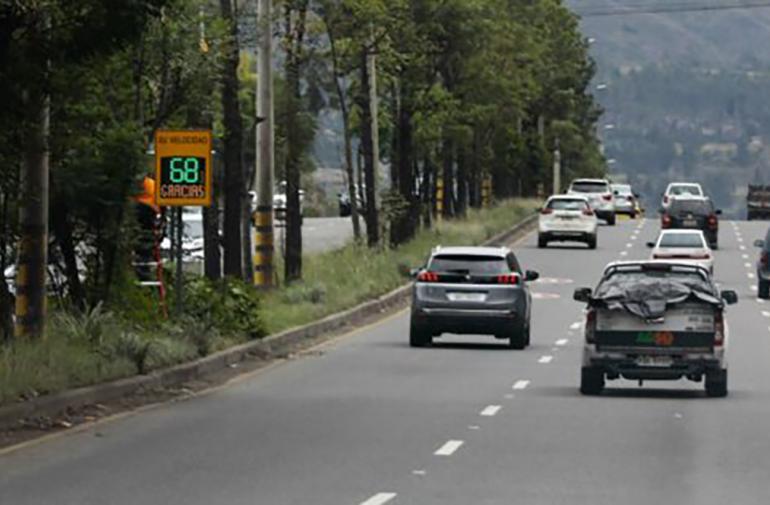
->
[[0, 221, 770, 505]]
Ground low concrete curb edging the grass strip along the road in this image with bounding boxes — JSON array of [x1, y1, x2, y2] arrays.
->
[[0, 211, 537, 428]]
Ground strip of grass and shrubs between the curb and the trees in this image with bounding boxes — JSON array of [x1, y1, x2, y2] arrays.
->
[[0, 200, 538, 405]]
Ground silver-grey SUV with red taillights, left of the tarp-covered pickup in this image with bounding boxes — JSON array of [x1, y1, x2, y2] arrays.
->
[[409, 247, 539, 349]]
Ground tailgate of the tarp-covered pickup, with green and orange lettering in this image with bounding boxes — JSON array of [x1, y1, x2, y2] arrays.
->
[[595, 304, 715, 354]]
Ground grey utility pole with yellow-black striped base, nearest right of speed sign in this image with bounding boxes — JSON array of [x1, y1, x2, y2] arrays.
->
[[254, 0, 274, 288]]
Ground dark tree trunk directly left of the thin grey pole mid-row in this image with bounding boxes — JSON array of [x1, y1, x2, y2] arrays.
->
[[357, 48, 380, 247]]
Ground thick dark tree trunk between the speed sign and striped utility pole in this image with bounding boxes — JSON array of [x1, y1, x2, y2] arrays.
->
[[219, 0, 245, 279]]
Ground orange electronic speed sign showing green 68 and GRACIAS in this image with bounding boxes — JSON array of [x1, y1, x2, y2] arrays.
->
[[155, 130, 212, 207]]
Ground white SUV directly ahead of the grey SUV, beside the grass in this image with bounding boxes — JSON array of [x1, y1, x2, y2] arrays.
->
[[537, 195, 598, 249]]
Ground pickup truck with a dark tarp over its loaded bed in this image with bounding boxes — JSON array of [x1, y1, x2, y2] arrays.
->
[[574, 260, 738, 397]]
